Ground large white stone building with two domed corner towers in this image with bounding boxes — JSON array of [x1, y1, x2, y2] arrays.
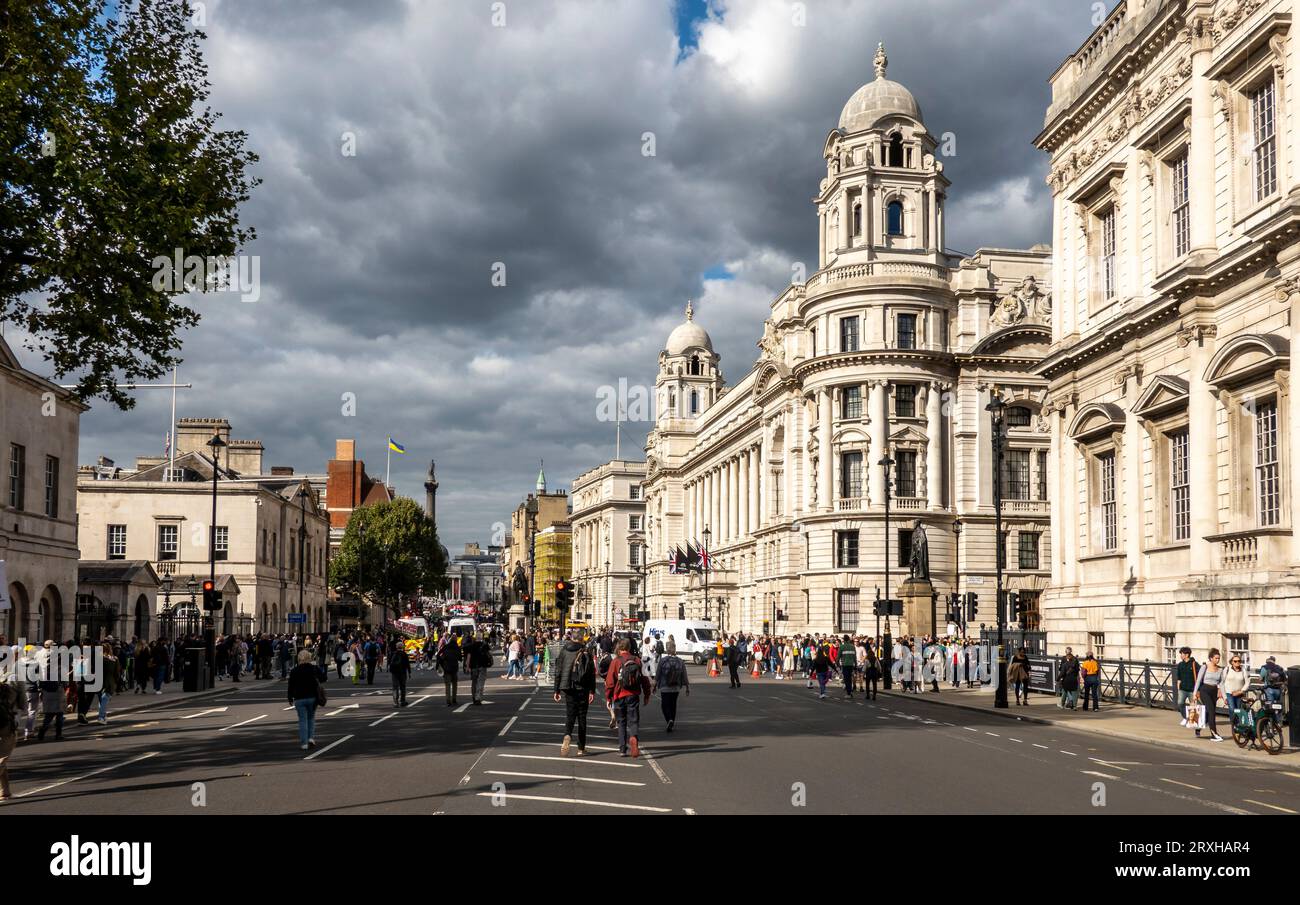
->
[[645, 48, 1052, 633]]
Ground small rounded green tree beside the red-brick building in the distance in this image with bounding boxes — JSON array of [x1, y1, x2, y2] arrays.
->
[[329, 497, 447, 626]]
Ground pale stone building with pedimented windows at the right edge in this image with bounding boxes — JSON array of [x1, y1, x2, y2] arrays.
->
[[1036, 0, 1300, 666]]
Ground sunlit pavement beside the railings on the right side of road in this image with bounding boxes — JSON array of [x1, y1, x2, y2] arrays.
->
[[881, 683, 1300, 770]]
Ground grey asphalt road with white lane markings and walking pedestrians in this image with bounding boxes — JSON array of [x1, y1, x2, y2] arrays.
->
[[0, 667, 1300, 817]]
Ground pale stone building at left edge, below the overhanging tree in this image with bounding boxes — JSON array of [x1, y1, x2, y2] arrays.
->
[[0, 338, 86, 644]]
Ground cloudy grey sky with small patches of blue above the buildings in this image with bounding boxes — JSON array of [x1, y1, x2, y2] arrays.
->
[[68, 0, 1113, 551]]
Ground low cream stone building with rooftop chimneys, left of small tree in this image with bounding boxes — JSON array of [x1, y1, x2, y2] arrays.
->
[[77, 419, 329, 633]]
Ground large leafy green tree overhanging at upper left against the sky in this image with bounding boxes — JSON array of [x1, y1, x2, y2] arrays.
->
[[0, 0, 260, 408]]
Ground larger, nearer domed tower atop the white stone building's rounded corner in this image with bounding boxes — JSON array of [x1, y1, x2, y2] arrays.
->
[[815, 44, 949, 268]]
